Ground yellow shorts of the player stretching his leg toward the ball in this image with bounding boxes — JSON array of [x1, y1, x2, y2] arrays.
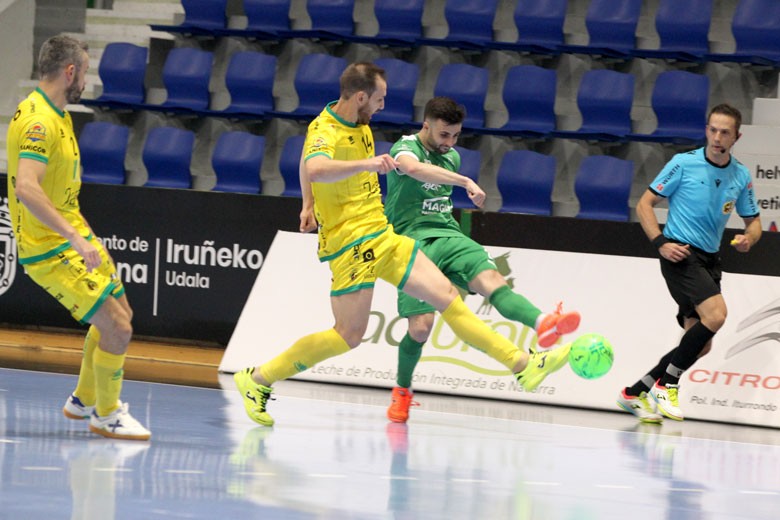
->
[[329, 227, 419, 296]]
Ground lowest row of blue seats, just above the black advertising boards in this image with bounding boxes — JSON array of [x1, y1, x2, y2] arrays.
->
[[79, 121, 634, 221]]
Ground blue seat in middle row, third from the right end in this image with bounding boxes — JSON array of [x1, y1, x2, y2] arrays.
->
[[485, 65, 557, 137]]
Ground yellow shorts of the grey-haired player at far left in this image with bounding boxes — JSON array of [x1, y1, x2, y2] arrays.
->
[[24, 238, 125, 323]]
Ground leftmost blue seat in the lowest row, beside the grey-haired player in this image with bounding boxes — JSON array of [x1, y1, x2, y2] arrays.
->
[[79, 121, 130, 184]]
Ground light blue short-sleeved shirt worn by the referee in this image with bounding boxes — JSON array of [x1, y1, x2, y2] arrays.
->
[[649, 148, 759, 253]]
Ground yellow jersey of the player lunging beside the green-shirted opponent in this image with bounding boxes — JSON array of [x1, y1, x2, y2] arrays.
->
[[303, 101, 388, 262]]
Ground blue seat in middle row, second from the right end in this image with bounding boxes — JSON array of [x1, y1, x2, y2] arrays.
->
[[553, 69, 634, 141]]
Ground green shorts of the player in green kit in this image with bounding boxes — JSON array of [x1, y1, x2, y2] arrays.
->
[[398, 235, 497, 318]]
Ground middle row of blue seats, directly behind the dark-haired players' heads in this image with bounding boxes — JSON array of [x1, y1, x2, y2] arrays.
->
[[82, 43, 709, 144]]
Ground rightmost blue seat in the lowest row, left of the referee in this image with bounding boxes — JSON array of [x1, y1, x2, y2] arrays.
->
[[574, 155, 634, 222]]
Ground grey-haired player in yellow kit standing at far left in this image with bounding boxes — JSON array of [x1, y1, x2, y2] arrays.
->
[[7, 36, 151, 440]]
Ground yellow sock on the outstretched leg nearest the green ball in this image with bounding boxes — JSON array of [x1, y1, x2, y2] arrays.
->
[[441, 296, 525, 371]]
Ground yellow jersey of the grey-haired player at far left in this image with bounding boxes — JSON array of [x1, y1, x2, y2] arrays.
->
[[6, 88, 91, 264]]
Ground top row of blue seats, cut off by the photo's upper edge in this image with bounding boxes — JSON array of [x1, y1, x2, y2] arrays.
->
[[151, 0, 780, 67]]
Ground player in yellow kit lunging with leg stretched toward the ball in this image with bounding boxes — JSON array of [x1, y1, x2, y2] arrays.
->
[[234, 63, 569, 426]]
